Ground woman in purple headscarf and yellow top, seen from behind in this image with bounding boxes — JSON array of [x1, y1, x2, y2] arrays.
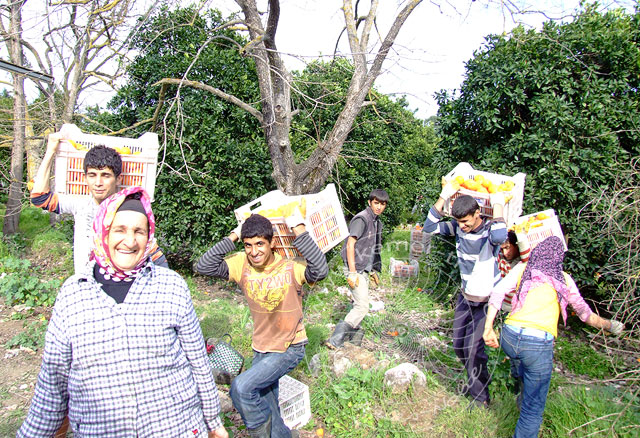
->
[[483, 236, 624, 438]]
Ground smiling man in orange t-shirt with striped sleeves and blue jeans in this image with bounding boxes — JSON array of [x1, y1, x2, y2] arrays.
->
[[196, 213, 329, 438]]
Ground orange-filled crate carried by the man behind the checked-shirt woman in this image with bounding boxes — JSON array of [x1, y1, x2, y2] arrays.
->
[[55, 126, 159, 199]]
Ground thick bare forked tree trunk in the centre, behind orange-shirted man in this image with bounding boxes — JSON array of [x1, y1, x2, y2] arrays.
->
[[158, 0, 422, 194]]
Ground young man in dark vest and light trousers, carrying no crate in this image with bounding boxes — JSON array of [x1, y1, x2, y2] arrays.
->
[[325, 189, 389, 349]]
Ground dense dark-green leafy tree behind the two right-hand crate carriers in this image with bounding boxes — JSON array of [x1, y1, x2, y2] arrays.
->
[[434, 6, 640, 294]]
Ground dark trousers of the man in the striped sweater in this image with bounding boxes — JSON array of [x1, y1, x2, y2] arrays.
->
[[453, 293, 491, 402]]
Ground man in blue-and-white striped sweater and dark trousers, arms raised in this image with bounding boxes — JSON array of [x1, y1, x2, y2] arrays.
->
[[423, 183, 507, 407]]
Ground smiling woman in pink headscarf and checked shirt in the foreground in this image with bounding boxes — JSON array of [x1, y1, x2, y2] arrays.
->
[[17, 187, 228, 438]]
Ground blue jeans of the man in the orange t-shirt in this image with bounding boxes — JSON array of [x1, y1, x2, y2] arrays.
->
[[229, 344, 306, 438]]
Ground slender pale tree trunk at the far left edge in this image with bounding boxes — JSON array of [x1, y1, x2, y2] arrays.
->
[[2, 0, 27, 235]]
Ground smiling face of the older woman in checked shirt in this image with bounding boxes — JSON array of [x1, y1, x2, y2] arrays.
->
[[108, 210, 149, 271]]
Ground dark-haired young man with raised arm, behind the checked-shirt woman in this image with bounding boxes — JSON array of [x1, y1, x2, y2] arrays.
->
[[31, 132, 168, 274]]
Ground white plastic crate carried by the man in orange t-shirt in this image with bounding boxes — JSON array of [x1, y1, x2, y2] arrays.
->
[[234, 184, 349, 258]]
